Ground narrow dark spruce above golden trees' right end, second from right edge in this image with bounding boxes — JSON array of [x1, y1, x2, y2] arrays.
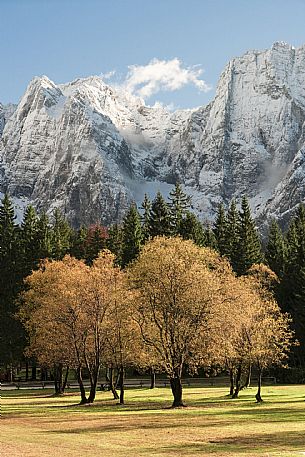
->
[[265, 220, 286, 278]]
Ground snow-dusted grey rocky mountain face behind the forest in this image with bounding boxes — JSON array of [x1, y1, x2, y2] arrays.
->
[[0, 43, 305, 226]]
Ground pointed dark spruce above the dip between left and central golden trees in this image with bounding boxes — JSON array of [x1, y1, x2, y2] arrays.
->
[[121, 203, 143, 267]]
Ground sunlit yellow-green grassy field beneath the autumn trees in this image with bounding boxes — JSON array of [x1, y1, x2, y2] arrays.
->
[[0, 386, 305, 457]]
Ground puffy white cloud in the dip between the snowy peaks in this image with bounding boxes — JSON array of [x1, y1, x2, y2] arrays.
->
[[103, 58, 211, 100]]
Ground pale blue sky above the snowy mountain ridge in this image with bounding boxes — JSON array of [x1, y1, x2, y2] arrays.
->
[[0, 0, 305, 108]]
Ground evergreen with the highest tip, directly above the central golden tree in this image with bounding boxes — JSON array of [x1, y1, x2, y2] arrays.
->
[[169, 182, 191, 235]]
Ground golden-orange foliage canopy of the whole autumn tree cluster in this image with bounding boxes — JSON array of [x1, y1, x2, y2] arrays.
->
[[20, 237, 292, 382]]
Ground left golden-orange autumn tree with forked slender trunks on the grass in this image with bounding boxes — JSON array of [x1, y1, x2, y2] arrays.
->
[[20, 251, 133, 403]]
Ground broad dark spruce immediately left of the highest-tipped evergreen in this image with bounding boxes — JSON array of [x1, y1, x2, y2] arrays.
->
[[149, 192, 172, 238]]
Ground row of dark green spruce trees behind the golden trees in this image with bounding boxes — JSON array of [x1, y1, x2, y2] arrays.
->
[[0, 184, 305, 377]]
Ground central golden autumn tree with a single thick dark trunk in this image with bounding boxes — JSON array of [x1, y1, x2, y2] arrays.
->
[[129, 237, 232, 407]]
